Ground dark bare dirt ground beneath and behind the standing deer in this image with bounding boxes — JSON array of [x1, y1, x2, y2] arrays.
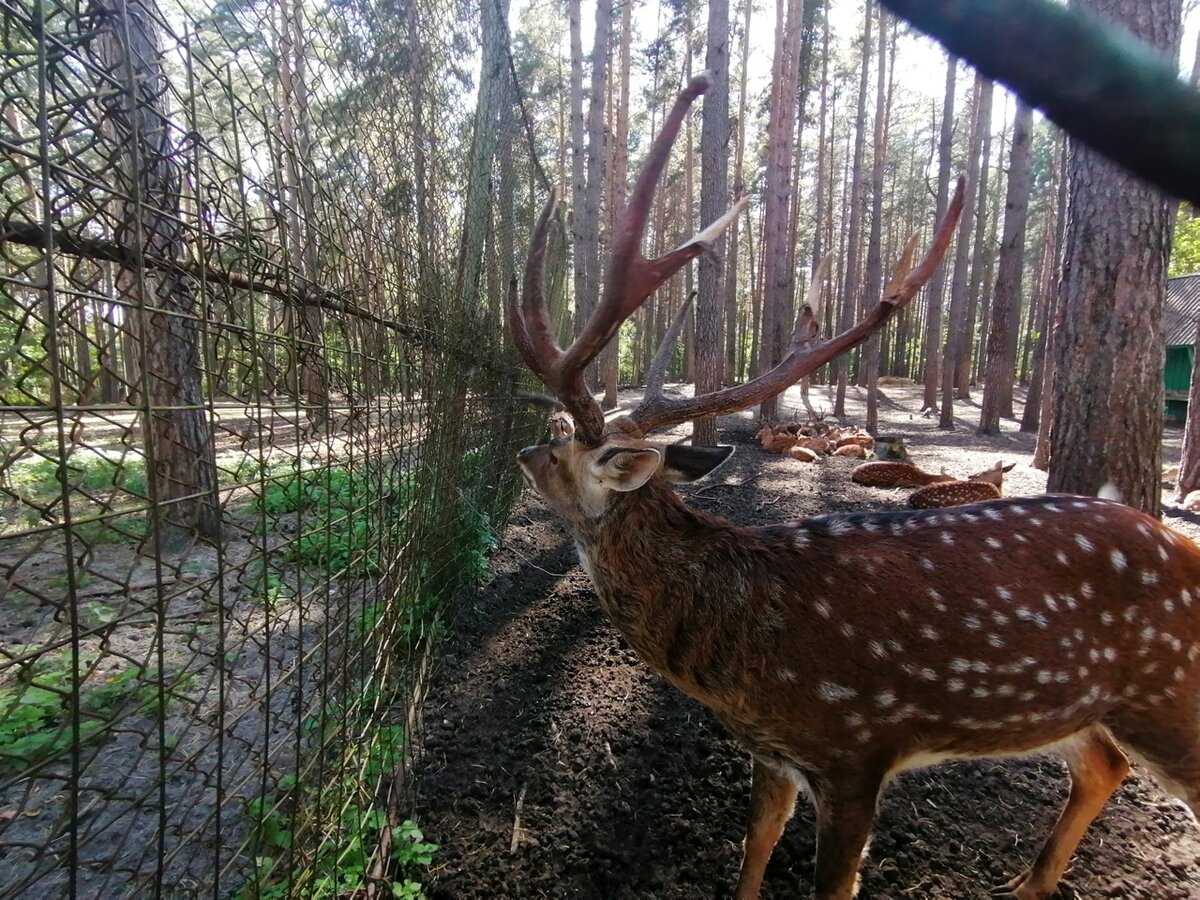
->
[[416, 386, 1200, 900]]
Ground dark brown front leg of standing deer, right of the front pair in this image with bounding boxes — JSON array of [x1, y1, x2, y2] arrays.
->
[[814, 773, 882, 900]]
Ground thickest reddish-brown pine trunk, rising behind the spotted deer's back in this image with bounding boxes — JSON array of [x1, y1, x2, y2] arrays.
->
[[1048, 0, 1181, 516]]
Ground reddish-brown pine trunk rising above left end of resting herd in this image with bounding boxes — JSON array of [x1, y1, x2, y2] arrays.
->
[[758, 0, 804, 419]]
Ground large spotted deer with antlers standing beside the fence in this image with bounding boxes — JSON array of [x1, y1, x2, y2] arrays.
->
[[509, 77, 1200, 900]]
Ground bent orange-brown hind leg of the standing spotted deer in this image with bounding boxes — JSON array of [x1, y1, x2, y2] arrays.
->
[[1002, 728, 1129, 900]]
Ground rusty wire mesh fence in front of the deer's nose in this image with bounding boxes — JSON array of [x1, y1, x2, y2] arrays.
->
[[0, 0, 544, 898]]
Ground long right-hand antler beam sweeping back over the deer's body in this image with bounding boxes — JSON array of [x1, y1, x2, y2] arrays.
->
[[630, 178, 966, 433]]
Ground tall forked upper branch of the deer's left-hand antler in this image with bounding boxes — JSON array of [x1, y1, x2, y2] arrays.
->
[[563, 72, 746, 382]]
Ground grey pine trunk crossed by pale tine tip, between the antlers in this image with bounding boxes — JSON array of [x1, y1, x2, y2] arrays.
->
[[691, 0, 733, 446]]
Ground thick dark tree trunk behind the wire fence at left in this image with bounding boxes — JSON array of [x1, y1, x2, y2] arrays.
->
[[96, 0, 221, 544]]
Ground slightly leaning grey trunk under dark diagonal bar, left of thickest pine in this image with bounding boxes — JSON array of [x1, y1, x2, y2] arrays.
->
[[979, 101, 1033, 434]]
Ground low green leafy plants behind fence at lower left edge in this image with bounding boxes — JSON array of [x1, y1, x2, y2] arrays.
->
[[0, 652, 171, 772]]
